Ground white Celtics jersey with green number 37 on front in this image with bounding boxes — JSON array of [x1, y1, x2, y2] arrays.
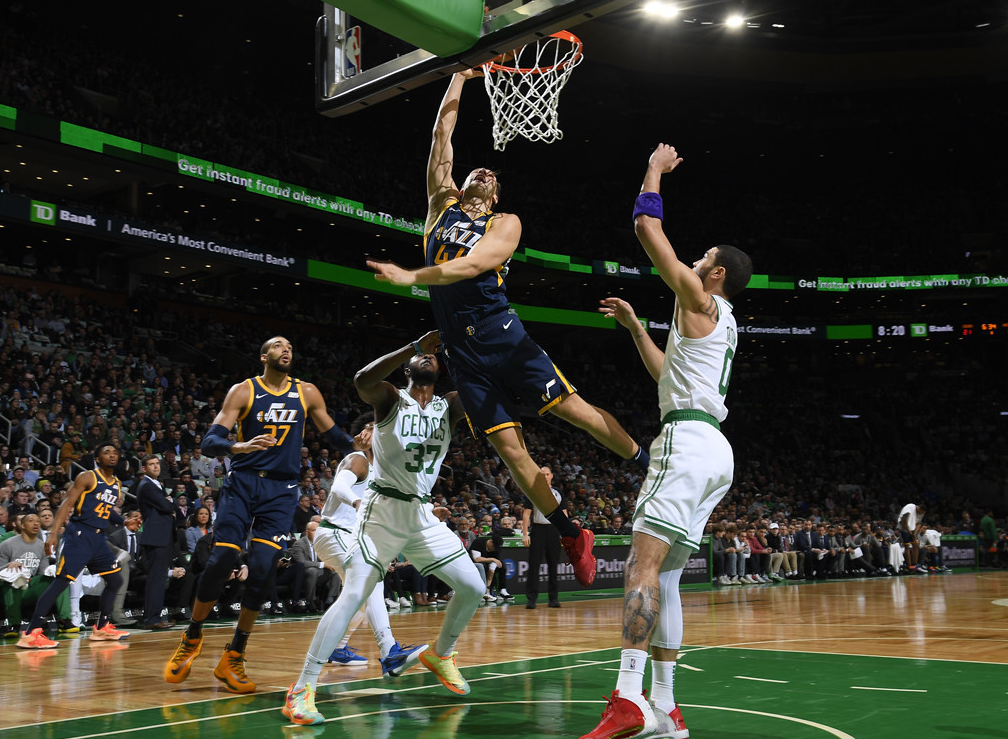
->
[[371, 388, 452, 499]]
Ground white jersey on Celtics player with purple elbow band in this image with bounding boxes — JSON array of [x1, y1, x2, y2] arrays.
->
[[658, 295, 739, 421]]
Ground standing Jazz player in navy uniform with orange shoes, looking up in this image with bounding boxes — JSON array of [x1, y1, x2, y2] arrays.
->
[[164, 336, 353, 693]]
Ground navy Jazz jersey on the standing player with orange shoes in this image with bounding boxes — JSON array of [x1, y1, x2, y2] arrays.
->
[[231, 377, 307, 480]]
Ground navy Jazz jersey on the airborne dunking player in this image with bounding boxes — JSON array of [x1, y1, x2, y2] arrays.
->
[[424, 195, 510, 336]]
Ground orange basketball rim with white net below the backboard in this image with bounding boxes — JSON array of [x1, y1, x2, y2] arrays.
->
[[483, 31, 584, 151]]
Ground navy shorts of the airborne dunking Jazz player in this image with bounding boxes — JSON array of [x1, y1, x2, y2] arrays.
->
[[443, 314, 577, 435]]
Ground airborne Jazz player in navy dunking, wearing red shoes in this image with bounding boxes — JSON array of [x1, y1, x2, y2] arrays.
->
[[368, 71, 647, 586]]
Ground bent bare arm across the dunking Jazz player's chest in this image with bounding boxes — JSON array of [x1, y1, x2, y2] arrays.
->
[[368, 213, 521, 286]]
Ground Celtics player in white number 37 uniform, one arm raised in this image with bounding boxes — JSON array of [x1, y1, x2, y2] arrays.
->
[[283, 332, 486, 725]]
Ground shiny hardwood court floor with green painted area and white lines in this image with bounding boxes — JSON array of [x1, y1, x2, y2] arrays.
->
[[0, 572, 1008, 739]]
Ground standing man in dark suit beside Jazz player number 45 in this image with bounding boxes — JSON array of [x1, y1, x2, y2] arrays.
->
[[136, 455, 176, 631]]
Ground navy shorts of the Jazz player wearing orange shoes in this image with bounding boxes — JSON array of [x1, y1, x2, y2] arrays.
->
[[214, 470, 299, 549]]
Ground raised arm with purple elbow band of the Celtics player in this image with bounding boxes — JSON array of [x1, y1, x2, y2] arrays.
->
[[633, 144, 711, 313]]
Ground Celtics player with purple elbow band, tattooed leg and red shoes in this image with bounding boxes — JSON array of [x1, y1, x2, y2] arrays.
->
[[582, 144, 752, 739]]
